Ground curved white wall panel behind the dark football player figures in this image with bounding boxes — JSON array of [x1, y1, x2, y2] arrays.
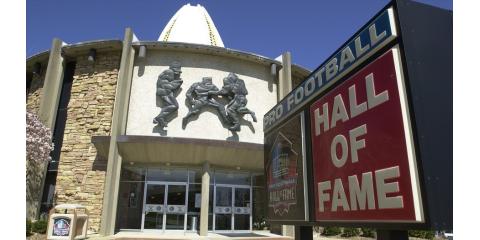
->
[[126, 50, 277, 144]]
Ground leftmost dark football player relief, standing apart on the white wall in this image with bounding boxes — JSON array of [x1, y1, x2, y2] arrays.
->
[[153, 62, 183, 129]]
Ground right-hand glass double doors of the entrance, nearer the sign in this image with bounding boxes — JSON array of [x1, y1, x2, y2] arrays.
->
[[213, 184, 252, 232]]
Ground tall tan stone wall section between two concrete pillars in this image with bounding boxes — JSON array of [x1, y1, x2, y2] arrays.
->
[[55, 51, 121, 231]]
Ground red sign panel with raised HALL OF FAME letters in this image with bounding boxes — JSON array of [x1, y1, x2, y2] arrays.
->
[[310, 48, 423, 222]]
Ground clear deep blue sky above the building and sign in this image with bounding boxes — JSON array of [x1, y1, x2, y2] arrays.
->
[[26, 0, 453, 70]]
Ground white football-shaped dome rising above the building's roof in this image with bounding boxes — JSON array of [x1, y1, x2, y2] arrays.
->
[[158, 3, 225, 47]]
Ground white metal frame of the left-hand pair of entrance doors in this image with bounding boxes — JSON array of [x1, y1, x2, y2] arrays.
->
[[141, 179, 188, 233]]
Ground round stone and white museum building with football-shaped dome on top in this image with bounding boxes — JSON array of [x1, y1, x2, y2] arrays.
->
[[26, 4, 310, 235]]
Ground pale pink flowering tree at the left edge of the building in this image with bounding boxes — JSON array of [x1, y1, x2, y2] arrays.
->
[[27, 110, 53, 163]]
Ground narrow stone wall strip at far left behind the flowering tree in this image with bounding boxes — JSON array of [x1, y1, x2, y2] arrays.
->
[[25, 66, 47, 219]]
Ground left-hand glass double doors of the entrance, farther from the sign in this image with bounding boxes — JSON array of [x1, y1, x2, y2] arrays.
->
[[142, 181, 188, 231]]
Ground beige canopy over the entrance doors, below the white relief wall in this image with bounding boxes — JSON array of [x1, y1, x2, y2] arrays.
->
[[92, 135, 263, 171]]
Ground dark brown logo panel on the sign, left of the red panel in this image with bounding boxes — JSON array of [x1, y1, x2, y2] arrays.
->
[[265, 113, 308, 221]]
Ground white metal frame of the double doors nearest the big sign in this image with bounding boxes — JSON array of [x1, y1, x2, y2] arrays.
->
[[212, 184, 253, 233]]
